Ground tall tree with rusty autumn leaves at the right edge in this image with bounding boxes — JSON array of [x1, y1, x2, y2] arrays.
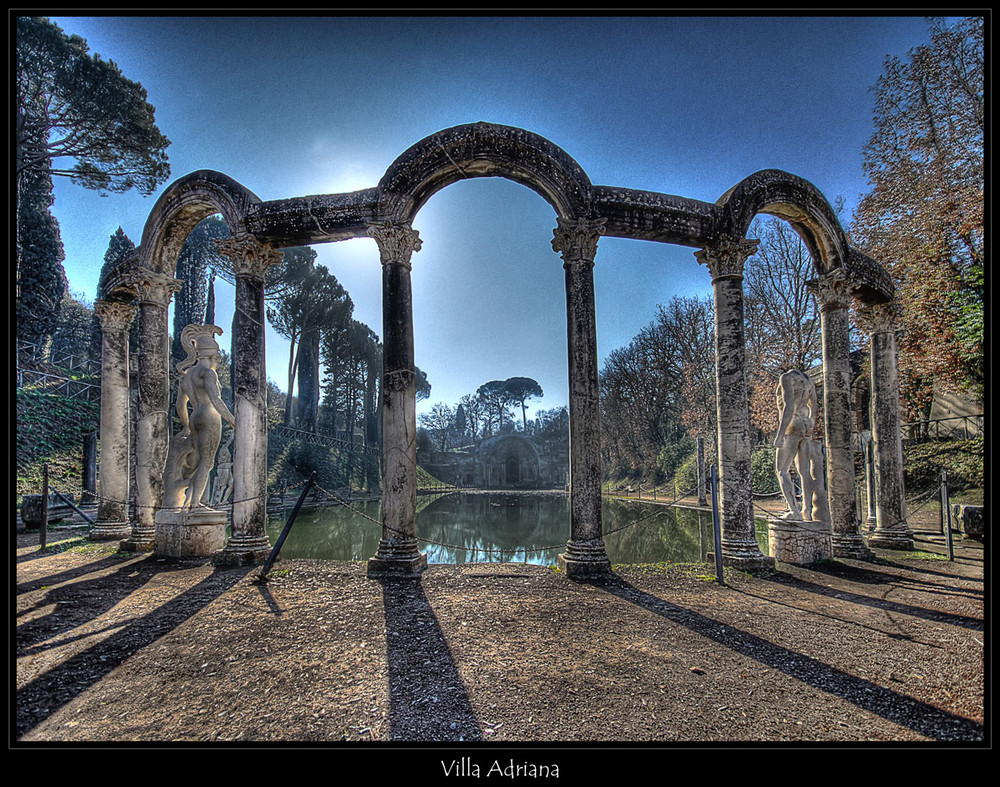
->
[[852, 17, 986, 403]]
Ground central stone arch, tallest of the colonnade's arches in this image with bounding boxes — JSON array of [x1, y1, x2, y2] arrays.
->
[[378, 122, 593, 223]]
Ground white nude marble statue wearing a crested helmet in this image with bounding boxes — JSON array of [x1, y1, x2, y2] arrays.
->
[[163, 324, 236, 510]]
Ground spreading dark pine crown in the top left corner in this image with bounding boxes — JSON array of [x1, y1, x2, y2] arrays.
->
[[16, 16, 170, 194]]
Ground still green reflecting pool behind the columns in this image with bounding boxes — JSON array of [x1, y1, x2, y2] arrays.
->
[[268, 493, 767, 565]]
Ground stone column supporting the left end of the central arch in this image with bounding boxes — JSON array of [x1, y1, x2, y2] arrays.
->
[[368, 221, 427, 576]]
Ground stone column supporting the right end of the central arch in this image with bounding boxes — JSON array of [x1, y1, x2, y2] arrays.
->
[[552, 218, 611, 576]]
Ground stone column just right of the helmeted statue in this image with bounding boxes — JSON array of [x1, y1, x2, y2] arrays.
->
[[212, 234, 281, 566]]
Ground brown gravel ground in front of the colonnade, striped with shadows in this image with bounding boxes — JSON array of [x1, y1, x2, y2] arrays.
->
[[11, 529, 991, 778]]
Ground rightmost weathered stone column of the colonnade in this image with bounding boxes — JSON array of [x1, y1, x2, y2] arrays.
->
[[858, 303, 913, 549]]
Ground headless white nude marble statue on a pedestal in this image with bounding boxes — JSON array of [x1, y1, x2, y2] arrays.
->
[[774, 369, 830, 522]]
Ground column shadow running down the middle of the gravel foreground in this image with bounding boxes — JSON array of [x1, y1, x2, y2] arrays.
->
[[377, 578, 482, 742]]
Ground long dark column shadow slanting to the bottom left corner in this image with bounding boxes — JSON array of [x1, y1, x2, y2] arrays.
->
[[16, 564, 251, 738]]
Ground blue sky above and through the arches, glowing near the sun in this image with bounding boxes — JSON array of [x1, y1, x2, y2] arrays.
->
[[39, 16, 944, 418]]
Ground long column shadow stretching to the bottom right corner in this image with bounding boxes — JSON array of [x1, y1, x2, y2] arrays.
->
[[589, 575, 984, 741]]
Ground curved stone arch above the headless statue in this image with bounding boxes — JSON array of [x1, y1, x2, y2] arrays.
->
[[716, 169, 849, 274]]
